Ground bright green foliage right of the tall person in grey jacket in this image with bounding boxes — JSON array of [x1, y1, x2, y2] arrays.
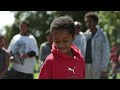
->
[[98, 11, 120, 45]]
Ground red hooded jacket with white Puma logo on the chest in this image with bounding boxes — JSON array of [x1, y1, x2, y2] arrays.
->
[[39, 45, 85, 79]]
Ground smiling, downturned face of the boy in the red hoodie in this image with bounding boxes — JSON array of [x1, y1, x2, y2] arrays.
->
[[52, 30, 74, 54]]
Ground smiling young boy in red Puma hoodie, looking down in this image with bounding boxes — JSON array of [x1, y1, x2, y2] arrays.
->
[[39, 16, 85, 79]]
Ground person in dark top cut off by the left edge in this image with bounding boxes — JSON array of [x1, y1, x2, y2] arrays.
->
[[0, 35, 9, 79]]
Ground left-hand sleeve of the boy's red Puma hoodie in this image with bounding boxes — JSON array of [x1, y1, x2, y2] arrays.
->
[[39, 59, 52, 79]]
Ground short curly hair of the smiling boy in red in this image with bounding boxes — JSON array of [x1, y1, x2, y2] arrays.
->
[[50, 16, 75, 36]]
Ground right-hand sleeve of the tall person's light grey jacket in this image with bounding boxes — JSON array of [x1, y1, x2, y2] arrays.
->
[[101, 33, 110, 71]]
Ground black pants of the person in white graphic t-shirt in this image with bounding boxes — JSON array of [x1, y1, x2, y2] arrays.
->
[[3, 69, 33, 79]]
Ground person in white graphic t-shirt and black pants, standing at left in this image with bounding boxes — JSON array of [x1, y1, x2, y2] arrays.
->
[[5, 21, 39, 79]]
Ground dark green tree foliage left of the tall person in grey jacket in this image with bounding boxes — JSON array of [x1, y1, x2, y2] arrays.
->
[[5, 11, 86, 46]]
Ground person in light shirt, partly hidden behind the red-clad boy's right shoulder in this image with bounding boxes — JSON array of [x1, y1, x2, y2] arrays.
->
[[73, 21, 86, 56]]
